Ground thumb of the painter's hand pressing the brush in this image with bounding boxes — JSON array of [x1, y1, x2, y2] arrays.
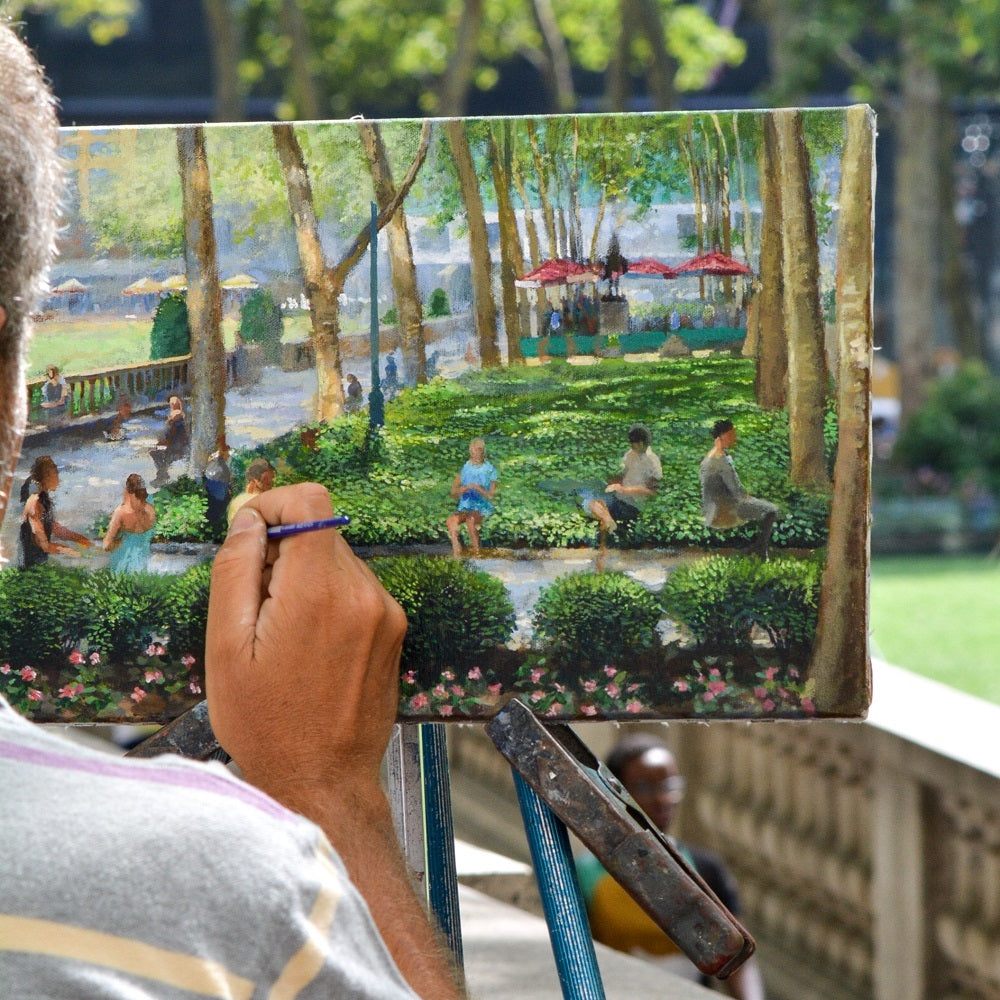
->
[[206, 507, 267, 662]]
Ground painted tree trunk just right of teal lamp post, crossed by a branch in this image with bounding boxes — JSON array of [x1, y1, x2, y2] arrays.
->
[[358, 121, 427, 385]]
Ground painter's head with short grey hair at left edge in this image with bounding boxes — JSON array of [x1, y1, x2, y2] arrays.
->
[[0, 22, 62, 548]]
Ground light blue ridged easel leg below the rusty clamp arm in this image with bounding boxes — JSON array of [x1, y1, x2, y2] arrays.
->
[[513, 771, 605, 1000]]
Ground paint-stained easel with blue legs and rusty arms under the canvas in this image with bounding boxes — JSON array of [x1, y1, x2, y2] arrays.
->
[[130, 700, 754, 1000]]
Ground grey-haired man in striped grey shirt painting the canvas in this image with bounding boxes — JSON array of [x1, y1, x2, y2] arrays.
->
[[0, 22, 461, 1000]]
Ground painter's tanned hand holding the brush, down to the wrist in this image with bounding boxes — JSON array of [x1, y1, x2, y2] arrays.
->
[[206, 484, 406, 798]]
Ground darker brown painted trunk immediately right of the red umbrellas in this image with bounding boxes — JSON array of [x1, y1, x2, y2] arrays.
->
[[747, 116, 788, 410]]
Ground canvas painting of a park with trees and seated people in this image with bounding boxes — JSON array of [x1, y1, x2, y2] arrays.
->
[[0, 106, 874, 722]]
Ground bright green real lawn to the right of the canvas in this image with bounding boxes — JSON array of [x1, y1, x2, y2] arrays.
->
[[871, 554, 1000, 704]]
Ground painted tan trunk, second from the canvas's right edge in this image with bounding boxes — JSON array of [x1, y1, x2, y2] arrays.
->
[[774, 110, 828, 489]]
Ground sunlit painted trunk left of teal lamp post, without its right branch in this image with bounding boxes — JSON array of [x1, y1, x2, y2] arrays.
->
[[271, 124, 344, 420]]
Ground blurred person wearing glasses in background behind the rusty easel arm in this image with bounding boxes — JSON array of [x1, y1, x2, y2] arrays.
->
[[576, 732, 764, 1000]]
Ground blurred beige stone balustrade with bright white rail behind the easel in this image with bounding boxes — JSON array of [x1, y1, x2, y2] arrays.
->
[[449, 662, 1000, 1000]]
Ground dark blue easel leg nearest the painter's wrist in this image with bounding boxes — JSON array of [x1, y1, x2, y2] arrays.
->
[[420, 722, 463, 969]]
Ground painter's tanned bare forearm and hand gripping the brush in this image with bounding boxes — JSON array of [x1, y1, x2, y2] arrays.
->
[[206, 484, 461, 1000]]
